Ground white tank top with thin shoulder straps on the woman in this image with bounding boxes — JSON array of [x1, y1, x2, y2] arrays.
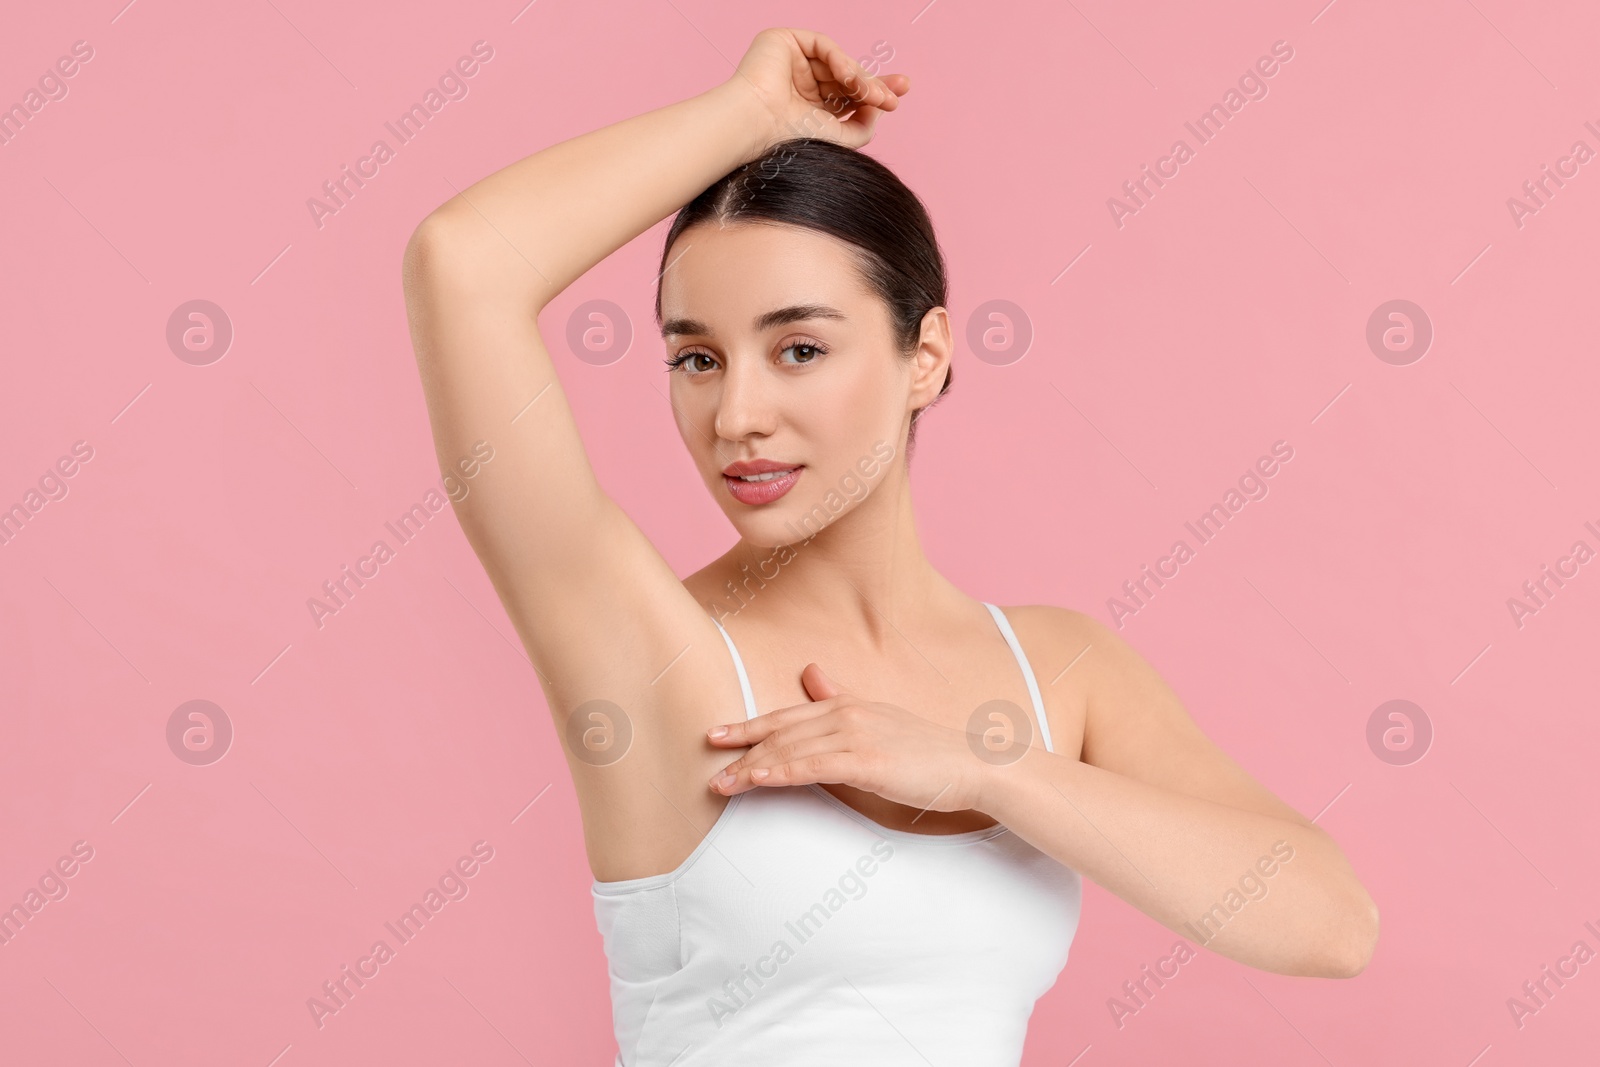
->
[[592, 603, 1082, 1067]]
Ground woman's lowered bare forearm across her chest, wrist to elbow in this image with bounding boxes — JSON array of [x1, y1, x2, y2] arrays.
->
[[979, 750, 1378, 977]]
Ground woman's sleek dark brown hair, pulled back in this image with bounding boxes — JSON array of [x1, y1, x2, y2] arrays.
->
[[656, 138, 955, 462]]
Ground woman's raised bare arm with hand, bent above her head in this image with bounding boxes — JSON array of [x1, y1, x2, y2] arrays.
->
[[403, 29, 896, 694]]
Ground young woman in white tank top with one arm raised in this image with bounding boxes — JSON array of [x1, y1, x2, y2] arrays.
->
[[405, 29, 1378, 1067]]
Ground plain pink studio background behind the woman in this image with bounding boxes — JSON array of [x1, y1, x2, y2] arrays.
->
[[0, 0, 1600, 1067]]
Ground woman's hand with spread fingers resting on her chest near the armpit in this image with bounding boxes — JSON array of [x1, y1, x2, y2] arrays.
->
[[707, 662, 987, 811]]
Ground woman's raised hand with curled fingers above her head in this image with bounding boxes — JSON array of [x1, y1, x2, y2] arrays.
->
[[731, 29, 910, 149]]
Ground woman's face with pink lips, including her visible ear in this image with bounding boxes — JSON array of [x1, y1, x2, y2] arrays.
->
[[661, 222, 947, 547]]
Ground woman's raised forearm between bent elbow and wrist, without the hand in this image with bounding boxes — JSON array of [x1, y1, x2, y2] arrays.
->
[[419, 75, 779, 312]]
